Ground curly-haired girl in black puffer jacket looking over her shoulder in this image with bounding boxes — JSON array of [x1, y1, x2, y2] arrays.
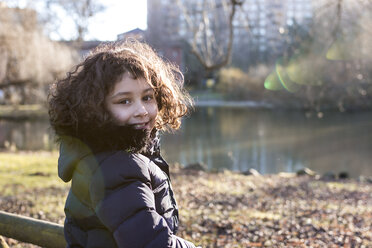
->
[[49, 41, 199, 248]]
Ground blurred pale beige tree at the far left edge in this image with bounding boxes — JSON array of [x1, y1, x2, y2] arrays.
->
[[0, 6, 78, 104]]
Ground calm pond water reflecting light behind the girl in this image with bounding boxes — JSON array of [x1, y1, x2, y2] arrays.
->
[[0, 107, 372, 177]]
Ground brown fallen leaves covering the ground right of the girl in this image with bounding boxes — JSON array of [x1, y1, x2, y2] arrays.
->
[[173, 170, 372, 248]]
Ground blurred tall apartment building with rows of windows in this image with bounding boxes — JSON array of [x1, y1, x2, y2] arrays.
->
[[147, 0, 316, 68]]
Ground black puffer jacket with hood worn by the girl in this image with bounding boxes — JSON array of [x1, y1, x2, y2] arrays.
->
[[58, 138, 195, 248]]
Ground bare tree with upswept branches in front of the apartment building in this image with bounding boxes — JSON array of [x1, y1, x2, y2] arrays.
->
[[177, 0, 244, 72]]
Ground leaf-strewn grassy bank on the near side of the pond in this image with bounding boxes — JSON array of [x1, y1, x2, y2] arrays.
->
[[0, 152, 372, 247]]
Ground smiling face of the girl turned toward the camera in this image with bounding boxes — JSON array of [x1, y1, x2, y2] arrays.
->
[[105, 73, 158, 131]]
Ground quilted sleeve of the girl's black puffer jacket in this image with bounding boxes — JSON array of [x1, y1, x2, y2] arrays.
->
[[90, 152, 195, 248]]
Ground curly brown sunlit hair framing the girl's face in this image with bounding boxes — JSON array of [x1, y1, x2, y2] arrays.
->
[[48, 40, 192, 140]]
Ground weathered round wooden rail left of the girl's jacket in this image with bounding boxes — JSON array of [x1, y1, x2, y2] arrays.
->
[[0, 211, 66, 248]]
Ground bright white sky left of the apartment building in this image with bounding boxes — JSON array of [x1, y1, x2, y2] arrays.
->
[[59, 0, 147, 41]]
